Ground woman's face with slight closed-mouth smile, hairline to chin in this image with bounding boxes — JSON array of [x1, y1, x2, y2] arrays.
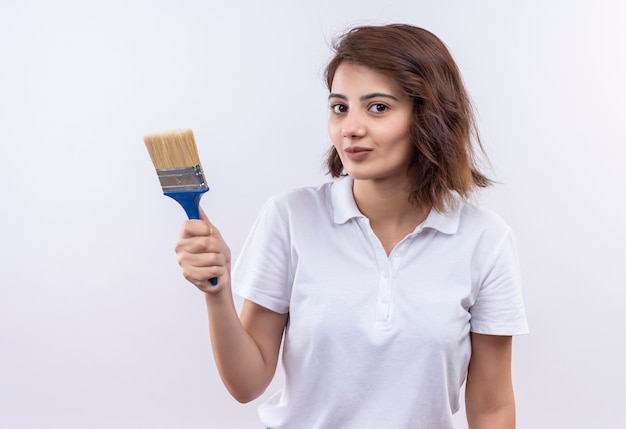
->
[[328, 62, 414, 181]]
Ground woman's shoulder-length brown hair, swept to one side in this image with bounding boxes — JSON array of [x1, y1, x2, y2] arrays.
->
[[325, 24, 492, 211]]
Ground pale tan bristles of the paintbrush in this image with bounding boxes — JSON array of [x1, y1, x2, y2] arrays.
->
[[143, 130, 200, 170]]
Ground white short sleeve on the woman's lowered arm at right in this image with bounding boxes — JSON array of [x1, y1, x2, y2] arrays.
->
[[470, 229, 528, 335]]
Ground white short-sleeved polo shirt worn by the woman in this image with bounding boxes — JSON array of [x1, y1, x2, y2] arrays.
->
[[233, 177, 528, 429]]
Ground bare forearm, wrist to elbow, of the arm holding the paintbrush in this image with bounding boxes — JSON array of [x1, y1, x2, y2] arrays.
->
[[205, 288, 275, 402]]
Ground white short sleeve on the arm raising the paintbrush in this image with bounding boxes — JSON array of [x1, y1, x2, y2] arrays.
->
[[232, 198, 293, 314]]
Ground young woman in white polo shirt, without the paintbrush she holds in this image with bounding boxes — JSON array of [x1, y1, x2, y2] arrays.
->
[[176, 25, 527, 429]]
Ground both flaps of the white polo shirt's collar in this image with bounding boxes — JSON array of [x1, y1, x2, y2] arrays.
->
[[331, 176, 461, 234]]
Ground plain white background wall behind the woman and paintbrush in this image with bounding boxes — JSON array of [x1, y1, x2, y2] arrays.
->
[[0, 0, 626, 429]]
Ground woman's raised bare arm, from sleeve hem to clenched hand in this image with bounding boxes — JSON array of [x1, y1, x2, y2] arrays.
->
[[176, 210, 287, 402]]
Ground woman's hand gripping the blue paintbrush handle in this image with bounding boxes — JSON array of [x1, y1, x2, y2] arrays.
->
[[175, 209, 230, 294]]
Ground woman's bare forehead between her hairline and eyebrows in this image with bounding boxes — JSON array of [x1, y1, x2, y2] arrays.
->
[[331, 62, 404, 97]]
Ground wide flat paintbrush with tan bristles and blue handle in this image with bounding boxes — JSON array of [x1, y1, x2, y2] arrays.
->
[[143, 130, 217, 285]]
